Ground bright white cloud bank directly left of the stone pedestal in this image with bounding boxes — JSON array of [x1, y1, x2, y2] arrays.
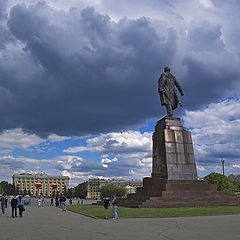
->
[[64, 131, 152, 179]]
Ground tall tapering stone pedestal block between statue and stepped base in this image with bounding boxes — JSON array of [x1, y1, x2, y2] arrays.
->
[[152, 117, 197, 180]]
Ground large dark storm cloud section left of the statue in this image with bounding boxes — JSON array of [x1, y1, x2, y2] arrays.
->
[[0, 3, 176, 135]]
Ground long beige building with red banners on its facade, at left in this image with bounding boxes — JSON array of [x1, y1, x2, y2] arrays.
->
[[12, 173, 69, 197]]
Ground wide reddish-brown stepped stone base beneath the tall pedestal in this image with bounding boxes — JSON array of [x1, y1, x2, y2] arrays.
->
[[119, 174, 240, 208]]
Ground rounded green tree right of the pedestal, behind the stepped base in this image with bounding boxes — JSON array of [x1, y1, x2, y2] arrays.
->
[[204, 172, 237, 192]]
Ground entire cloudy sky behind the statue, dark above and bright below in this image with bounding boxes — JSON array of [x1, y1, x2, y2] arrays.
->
[[0, 0, 240, 186]]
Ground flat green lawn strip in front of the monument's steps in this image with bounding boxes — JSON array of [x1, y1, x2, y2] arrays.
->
[[67, 205, 240, 218]]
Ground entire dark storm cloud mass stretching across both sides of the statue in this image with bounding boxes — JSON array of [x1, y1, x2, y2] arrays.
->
[[0, 1, 237, 136]]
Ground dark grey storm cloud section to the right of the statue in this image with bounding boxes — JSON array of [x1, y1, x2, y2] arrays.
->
[[182, 22, 240, 109]]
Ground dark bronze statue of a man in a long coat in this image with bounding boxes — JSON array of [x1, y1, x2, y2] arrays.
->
[[158, 67, 184, 117]]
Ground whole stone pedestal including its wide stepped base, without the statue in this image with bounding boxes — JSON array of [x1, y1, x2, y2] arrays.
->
[[119, 117, 240, 208]]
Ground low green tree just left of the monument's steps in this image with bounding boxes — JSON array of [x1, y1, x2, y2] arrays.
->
[[99, 184, 127, 199]]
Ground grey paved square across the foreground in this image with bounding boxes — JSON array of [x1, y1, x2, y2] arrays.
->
[[0, 206, 240, 240]]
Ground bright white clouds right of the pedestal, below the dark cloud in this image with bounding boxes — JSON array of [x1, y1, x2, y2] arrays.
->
[[183, 97, 240, 174]]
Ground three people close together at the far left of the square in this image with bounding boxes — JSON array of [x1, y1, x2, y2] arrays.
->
[[0, 194, 25, 218]]
